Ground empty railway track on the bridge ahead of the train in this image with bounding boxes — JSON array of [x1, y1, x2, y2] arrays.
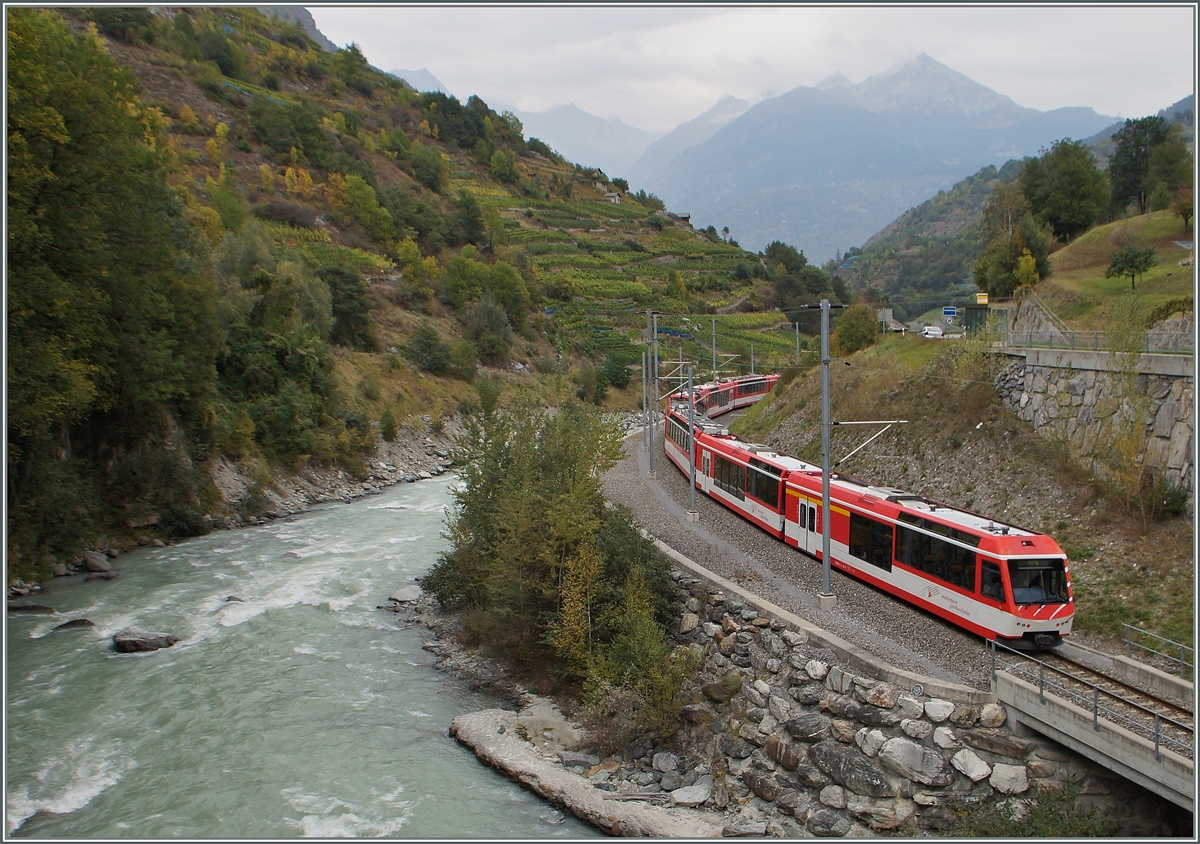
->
[[996, 650, 1195, 759]]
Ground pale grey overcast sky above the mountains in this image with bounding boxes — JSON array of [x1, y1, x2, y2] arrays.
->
[[308, 5, 1196, 132]]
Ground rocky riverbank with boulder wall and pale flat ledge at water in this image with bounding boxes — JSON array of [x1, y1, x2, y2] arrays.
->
[[398, 570, 1172, 838]]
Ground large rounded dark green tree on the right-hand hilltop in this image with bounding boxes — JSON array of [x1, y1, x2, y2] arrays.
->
[[1020, 138, 1110, 241]]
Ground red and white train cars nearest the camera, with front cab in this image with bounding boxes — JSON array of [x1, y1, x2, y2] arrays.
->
[[664, 386, 1075, 648]]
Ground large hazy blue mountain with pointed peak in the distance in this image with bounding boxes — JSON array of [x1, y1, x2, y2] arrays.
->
[[635, 54, 1115, 263]]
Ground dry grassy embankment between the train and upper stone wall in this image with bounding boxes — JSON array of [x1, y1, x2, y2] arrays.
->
[[733, 336, 1195, 648]]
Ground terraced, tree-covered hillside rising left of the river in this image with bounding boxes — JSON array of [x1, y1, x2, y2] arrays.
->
[[8, 8, 849, 575]]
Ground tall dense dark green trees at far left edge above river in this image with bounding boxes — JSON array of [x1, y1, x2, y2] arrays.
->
[[5, 8, 220, 567]]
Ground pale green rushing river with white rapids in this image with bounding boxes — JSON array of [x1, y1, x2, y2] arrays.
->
[[6, 475, 599, 839]]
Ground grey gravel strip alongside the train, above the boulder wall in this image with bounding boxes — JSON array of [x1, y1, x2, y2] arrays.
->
[[605, 435, 990, 689]]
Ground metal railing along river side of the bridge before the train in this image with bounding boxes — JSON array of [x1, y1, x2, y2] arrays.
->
[[990, 640, 1195, 761]]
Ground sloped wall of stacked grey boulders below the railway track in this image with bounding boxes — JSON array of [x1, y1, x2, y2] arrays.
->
[[648, 573, 1180, 837]]
